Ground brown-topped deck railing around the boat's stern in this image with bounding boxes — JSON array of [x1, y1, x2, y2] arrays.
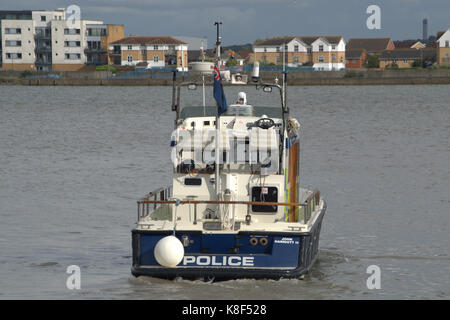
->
[[137, 187, 320, 224]]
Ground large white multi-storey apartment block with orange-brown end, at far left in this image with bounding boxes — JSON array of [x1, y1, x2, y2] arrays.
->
[[0, 9, 124, 71]]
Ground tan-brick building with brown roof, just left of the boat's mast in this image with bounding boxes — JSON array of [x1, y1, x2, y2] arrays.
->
[[109, 36, 188, 71]]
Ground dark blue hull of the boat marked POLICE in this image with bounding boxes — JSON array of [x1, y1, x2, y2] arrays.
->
[[131, 205, 326, 280]]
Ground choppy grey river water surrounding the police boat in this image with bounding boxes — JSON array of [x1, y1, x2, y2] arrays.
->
[[0, 86, 450, 299]]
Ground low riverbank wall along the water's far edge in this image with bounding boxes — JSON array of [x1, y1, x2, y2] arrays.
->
[[0, 69, 450, 86]]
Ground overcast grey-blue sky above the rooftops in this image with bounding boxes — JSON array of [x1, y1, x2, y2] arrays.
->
[[0, 0, 450, 47]]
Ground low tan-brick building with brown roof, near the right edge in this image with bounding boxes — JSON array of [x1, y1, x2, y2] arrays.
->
[[379, 48, 436, 69]]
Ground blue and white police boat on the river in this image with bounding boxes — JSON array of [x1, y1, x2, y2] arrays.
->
[[131, 25, 326, 280]]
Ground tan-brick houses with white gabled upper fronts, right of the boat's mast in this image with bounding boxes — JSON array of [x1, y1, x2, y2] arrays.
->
[[252, 36, 345, 70]]
